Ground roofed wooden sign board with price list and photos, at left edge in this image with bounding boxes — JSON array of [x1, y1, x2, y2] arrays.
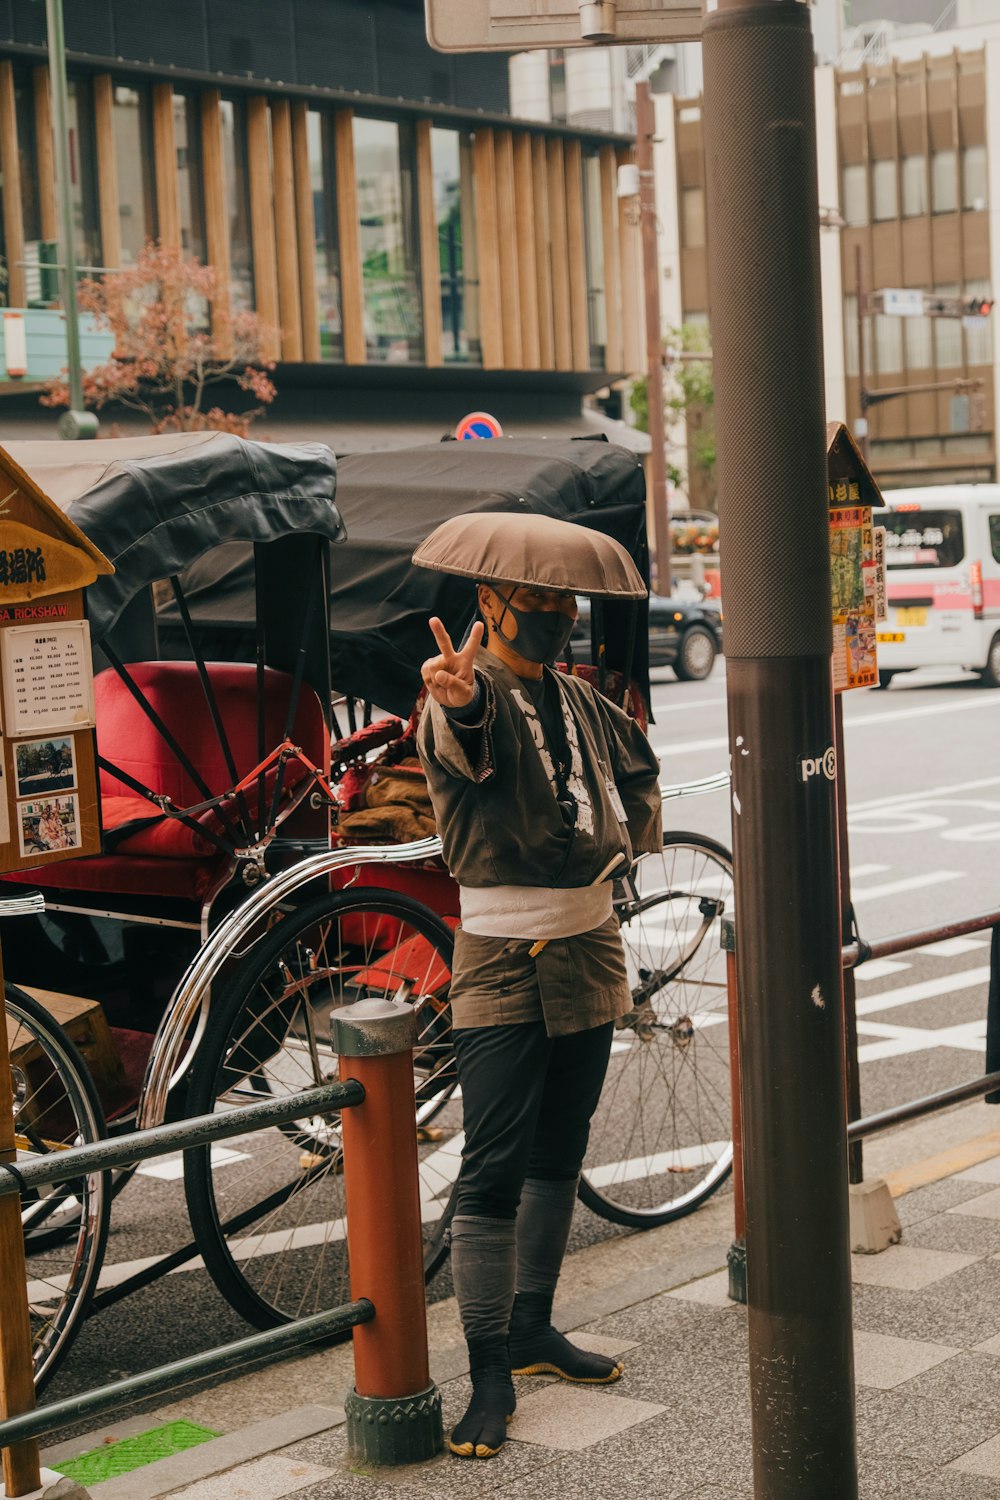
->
[[0, 447, 112, 873]]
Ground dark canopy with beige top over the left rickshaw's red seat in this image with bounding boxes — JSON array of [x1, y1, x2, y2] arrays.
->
[[4, 432, 345, 642]]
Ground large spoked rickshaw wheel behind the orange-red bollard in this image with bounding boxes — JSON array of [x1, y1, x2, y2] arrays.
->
[[184, 890, 462, 1328]]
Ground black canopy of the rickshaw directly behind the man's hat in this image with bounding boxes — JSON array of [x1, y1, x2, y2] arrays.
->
[[160, 438, 649, 717]]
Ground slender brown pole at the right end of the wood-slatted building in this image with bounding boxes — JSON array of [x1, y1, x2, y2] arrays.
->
[[636, 83, 673, 594]]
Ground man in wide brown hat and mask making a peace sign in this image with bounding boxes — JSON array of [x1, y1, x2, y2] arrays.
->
[[414, 513, 663, 1458]]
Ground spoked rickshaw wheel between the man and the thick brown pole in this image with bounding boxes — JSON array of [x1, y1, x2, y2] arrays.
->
[[580, 833, 733, 1229]]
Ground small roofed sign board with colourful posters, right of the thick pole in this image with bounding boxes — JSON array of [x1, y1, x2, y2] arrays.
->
[[826, 422, 885, 693]]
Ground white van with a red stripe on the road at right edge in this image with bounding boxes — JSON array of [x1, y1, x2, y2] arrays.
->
[[874, 485, 1000, 687]]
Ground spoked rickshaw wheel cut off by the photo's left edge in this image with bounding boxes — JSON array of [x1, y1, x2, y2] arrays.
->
[[4, 984, 111, 1389]]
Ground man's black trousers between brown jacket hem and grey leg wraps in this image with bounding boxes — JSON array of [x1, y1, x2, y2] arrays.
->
[[454, 1022, 615, 1220]]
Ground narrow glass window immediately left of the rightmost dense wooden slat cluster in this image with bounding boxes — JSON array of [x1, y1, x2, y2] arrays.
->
[[430, 129, 483, 363]]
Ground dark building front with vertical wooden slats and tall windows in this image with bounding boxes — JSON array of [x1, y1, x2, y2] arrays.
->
[[0, 0, 642, 438]]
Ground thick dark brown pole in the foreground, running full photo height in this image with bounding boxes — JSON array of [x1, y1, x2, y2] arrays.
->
[[703, 0, 858, 1500]]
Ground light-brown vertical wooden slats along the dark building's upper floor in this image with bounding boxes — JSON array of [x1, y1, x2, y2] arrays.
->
[[0, 60, 642, 387]]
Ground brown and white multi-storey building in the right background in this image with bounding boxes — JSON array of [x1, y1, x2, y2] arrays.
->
[[658, 13, 1000, 488]]
